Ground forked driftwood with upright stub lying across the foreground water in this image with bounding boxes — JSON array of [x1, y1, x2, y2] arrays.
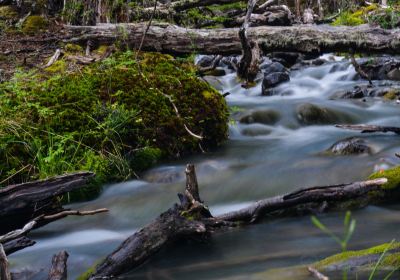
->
[[86, 164, 387, 279]]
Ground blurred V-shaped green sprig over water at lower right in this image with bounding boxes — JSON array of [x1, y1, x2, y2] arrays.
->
[[311, 211, 356, 252]]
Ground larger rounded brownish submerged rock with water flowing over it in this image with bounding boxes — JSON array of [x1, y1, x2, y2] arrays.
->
[[296, 103, 354, 125]]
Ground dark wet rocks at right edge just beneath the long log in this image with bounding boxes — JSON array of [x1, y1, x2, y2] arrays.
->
[[359, 56, 400, 81]]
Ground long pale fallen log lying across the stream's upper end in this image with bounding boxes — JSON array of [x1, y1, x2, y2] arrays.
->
[[62, 22, 400, 55]]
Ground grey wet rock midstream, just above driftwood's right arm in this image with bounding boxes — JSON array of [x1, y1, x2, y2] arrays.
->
[[327, 137, 372, 155]]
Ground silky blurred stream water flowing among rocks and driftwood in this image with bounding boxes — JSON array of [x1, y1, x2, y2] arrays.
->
[[10, 54, 400, 280]]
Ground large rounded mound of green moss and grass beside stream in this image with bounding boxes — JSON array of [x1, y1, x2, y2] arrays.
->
[[0, 52, 228, 189]]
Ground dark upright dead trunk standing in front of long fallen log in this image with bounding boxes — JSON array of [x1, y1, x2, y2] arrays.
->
[[238, 0, 261, 83]]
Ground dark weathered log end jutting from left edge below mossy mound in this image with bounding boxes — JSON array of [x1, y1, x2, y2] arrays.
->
[[0, 172, 94, 234]]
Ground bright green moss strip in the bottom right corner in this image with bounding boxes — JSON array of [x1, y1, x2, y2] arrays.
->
[[313, 242, 400, 268]]
